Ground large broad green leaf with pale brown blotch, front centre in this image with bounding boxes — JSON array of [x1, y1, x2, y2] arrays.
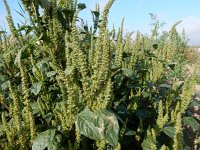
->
[[75, 108, 119, 146]]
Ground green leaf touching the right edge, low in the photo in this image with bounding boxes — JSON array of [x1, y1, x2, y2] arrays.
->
[[183, 117, 200, 132]]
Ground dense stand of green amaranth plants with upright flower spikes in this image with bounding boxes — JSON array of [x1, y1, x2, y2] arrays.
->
[[0, 0, 200, 150]]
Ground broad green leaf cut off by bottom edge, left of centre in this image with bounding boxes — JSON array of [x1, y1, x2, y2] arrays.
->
[[32, 129, 63, 150]]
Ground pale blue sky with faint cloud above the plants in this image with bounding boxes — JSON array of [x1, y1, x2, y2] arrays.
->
[[0, 0, 200, 45]]
